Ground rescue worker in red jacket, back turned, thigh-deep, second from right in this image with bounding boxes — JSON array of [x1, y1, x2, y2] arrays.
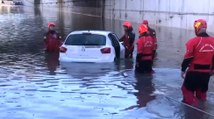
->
[[135, 24, 155, 73]]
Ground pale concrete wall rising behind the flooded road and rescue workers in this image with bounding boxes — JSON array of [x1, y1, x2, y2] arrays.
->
[[36, 0, 214, 32]]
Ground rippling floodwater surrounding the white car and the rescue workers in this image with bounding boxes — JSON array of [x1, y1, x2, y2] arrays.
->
[[0, 6, 214, 119]]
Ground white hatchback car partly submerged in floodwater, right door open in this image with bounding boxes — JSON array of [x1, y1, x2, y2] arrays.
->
[[59, 31, 125, 63]]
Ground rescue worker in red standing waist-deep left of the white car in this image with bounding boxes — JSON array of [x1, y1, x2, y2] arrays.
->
[[44, 22, 62, 52]]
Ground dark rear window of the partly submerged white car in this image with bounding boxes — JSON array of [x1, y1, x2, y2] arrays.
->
[[65, 34, 106, 46]]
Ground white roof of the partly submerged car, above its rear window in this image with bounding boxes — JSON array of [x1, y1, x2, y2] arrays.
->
[[69, 30, 112, 36]]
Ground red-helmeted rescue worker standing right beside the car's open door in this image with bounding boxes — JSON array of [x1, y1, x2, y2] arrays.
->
[[120, 21, 135, 58]]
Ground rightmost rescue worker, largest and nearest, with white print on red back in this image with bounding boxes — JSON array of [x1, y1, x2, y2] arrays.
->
[[181, 19, 214, 106]]
